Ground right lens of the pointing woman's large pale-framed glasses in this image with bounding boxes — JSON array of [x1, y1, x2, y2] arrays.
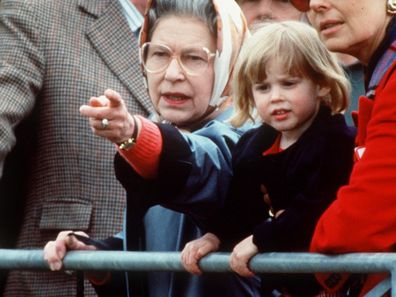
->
[[180, 48, 209, 74]]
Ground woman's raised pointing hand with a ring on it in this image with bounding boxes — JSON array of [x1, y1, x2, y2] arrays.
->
[[80, 90, 137, 144]]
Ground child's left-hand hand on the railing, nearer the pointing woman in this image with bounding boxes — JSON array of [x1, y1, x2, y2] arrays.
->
[[181, 233, 220, 275]]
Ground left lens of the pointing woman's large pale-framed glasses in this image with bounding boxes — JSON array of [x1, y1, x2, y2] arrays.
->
[[142, 43, 172, 72]]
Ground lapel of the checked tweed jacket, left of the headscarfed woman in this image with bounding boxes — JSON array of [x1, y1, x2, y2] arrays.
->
[[78, 0, 152, 112]]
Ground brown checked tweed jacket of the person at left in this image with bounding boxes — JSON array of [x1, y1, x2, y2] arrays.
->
[[0, 0, 152, 296]]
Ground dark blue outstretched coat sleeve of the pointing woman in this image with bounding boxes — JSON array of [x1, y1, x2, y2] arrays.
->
[[115, 121, 242, 223]]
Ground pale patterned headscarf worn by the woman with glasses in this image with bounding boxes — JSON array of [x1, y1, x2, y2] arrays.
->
[[140, 0, 249, 107]]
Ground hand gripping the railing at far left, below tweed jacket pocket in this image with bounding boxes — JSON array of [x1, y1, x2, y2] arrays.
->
[[44, 231, 97, 271]]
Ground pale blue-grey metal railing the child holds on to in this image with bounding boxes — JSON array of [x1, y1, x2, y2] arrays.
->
[[0, 249, 396, 297]]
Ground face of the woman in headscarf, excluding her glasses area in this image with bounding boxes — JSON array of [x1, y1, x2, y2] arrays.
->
[[147, 16, 216, 128]]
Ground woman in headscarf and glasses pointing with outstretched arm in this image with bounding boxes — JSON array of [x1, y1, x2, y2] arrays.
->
[[45, 0, 258, 297]]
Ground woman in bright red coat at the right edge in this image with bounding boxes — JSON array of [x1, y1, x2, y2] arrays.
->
[[292, 0, 396, 292]]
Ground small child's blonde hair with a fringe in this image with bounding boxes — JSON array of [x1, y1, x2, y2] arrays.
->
[[230, 21, 350, 127]]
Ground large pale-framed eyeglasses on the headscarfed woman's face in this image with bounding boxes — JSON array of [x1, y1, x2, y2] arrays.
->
[[140, 42, 216, 75]]
